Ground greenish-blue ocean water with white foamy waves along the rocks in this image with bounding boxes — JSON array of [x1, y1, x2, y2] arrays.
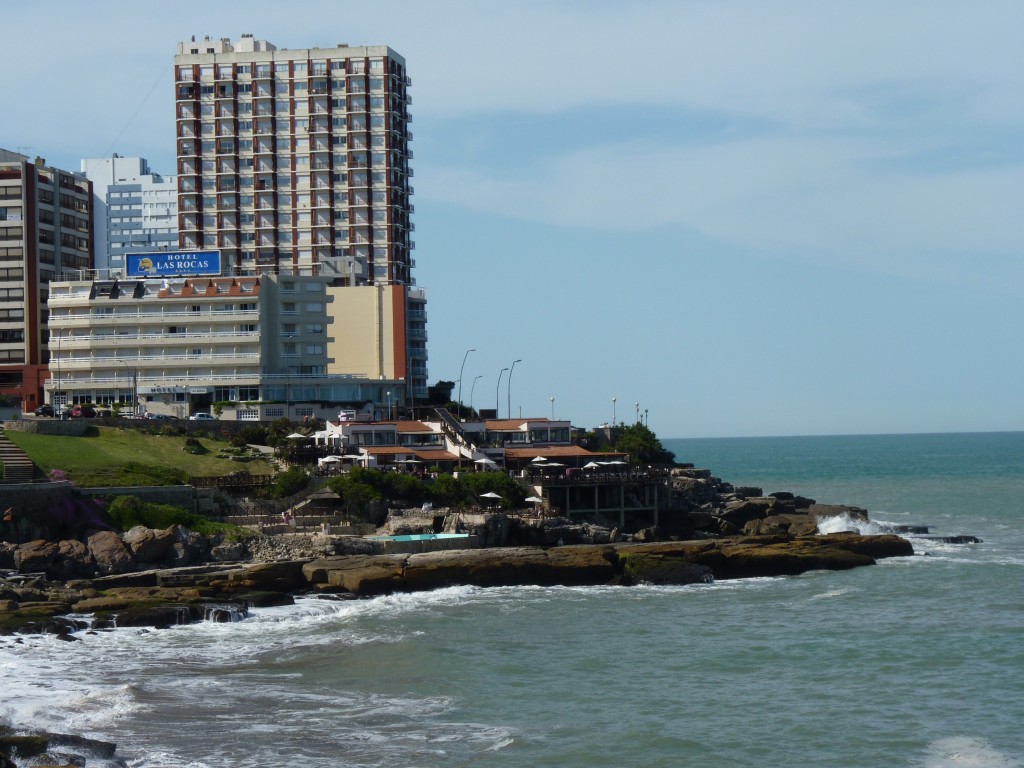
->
[[0, 433, 1024, 768]]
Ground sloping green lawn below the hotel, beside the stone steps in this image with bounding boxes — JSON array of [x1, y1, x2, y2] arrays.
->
[[6, 427, 274, 487]]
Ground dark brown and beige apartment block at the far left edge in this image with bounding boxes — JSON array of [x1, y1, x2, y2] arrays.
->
[[0, 150, 93, 411]]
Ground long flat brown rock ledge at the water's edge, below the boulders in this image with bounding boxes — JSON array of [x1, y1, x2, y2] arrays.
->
[[0, 534, 913, 637]]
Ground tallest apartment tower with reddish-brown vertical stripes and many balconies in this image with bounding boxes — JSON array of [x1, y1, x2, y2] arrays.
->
[[174, 35, 427, 401]]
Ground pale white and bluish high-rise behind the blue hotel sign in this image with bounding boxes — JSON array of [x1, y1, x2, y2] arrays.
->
[[82, 155, 178, 278]]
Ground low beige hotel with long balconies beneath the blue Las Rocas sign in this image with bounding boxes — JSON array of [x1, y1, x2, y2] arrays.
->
[[47, 274, 406, 421]]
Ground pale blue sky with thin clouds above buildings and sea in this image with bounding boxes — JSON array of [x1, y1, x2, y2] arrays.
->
[[0, 0, 1024, 437]]
